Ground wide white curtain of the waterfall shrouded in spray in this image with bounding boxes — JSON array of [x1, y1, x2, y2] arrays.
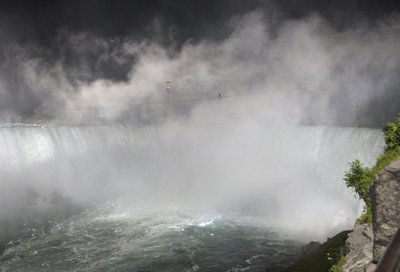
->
[[0, 124, 384, 239]]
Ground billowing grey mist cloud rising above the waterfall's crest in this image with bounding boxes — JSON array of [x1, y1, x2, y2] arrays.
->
[[1, 11, 400, 125]]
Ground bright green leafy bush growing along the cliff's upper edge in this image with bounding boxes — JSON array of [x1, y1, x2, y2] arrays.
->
[[344, 118, 400, 222]]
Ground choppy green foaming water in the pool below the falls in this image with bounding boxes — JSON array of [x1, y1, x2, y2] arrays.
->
[[0, 203, 299, 272]]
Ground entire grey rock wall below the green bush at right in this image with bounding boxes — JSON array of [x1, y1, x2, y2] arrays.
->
[[343, 160, 400, 272]]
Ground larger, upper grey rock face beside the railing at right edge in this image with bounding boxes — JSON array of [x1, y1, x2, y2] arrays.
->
[[371, 160, 400, 262]]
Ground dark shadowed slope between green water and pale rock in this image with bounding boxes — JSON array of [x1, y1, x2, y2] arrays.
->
[[285, 231, 349, 272]]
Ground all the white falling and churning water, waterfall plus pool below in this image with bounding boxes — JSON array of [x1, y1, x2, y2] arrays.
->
[[0, 124, 383, 271]]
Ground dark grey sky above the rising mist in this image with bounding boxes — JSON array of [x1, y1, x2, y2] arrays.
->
[[0, 0, 400, 41]]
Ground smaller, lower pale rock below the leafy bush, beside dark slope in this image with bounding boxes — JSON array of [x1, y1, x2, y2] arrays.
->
[[343, 222, 373, 272]]
